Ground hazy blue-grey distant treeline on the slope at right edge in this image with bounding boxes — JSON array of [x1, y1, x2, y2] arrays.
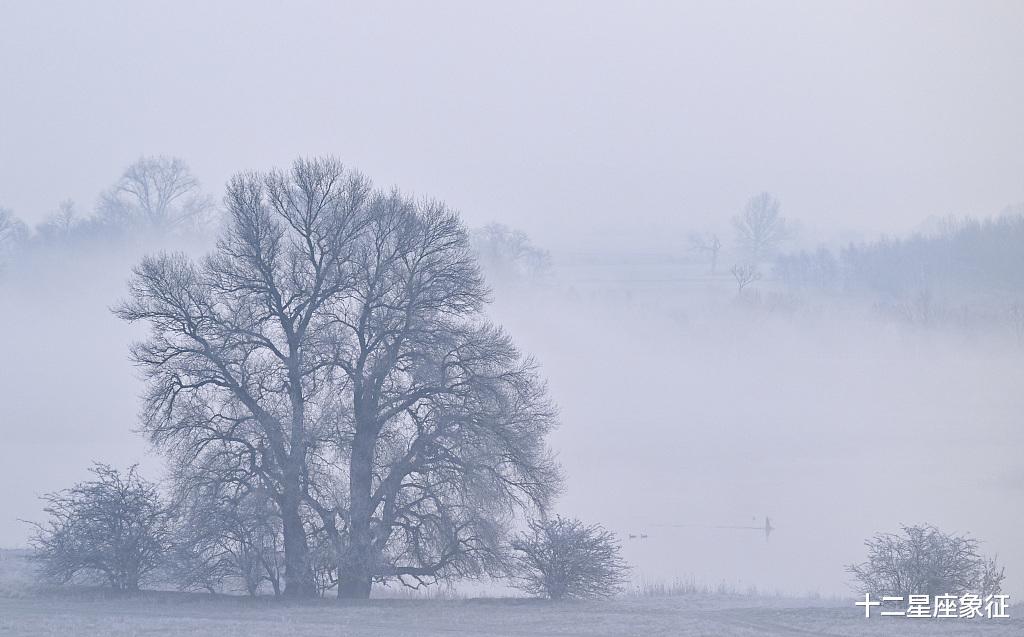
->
[[775, 212, 1024, 302]]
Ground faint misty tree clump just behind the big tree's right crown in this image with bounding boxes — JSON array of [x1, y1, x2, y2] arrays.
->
[[471, 223, 551, 282]]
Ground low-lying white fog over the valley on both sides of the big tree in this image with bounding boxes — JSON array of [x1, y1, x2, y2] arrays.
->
[[0, 244, 1024, 594]]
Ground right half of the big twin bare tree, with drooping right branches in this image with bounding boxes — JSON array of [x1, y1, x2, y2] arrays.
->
[[325, 194, 558, 597]]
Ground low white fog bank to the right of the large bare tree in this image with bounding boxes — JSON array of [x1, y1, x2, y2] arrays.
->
[[491, 282, 1024, 594]]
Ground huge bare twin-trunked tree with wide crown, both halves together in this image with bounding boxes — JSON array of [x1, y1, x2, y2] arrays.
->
[[119, 160, 558, 597]]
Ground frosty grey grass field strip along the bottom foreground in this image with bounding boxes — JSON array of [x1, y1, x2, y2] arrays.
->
[[0, 593, 1024, 637]]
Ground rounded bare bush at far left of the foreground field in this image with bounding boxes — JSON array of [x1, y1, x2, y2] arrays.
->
[[33, 464, 171, 591]]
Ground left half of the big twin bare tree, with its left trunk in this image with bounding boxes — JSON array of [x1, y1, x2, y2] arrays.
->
[[117, 160, 370, 596]]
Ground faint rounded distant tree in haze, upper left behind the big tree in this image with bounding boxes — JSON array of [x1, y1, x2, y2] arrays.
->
[[96, 157, 213, 233]]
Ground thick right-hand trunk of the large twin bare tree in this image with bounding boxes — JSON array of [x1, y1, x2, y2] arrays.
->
[[338, 429, 374, 599]]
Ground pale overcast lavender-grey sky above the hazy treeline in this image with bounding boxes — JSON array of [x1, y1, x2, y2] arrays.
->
[[0, 0, 1024, 245]]
